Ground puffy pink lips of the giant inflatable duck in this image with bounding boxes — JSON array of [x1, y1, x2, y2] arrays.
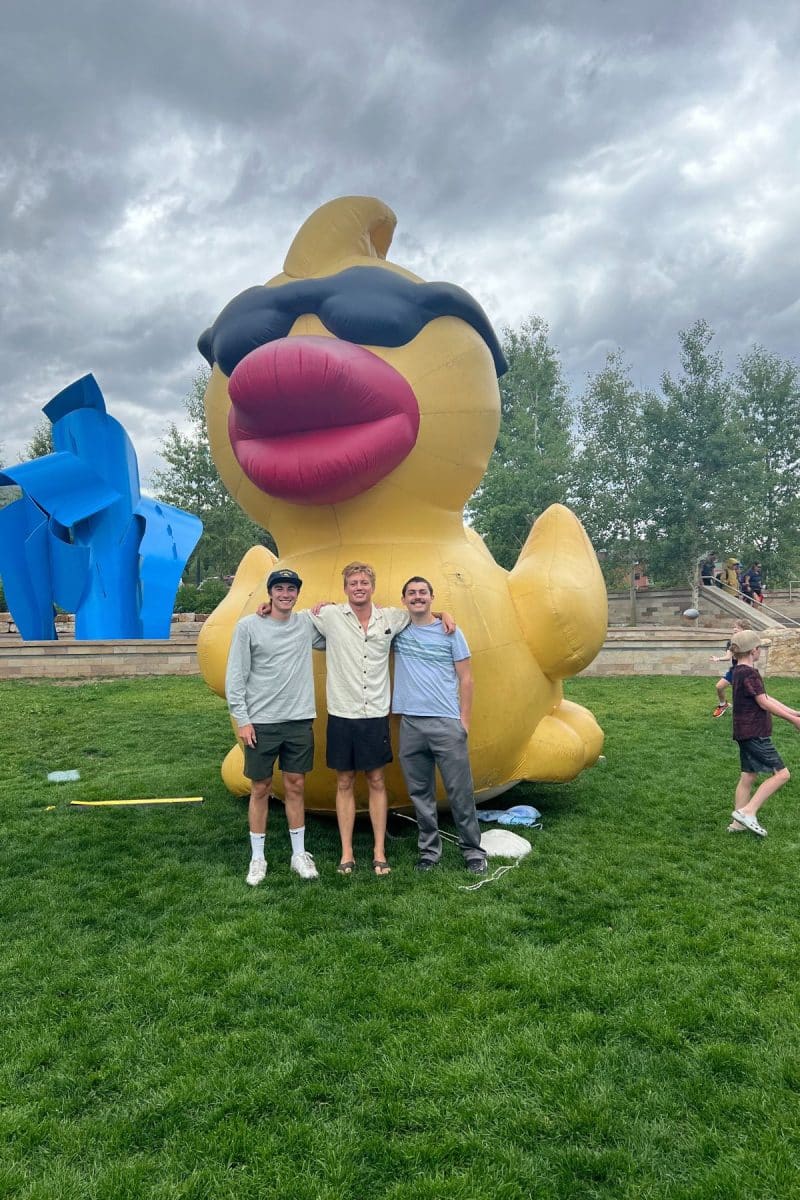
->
[[228, 337, 420, 504]]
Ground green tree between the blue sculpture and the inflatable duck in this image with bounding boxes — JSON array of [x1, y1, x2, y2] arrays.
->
[[152, 370, 275, 583]]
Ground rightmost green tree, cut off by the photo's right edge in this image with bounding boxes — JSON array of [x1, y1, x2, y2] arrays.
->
[[733, 346, 800, 583]]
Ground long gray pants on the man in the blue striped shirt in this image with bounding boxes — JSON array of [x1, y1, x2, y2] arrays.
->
[[399, 716, 486, 863]]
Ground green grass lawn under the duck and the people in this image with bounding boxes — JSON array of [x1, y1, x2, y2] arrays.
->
[[0, 678, 800, 1200]]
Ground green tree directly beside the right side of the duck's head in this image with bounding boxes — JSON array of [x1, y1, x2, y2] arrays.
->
[[468, 317, 572, 568]]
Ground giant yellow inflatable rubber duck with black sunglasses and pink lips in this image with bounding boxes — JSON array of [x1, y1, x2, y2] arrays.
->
[[198, 197, 607, 812]]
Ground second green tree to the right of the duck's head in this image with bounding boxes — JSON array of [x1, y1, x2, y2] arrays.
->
[[573, 350, 652, 600]]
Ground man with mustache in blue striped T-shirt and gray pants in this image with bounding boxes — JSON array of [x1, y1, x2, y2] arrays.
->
[[392, 575, 487, 875]]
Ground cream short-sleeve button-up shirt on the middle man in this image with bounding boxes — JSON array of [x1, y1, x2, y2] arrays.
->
[[311, 604, 410, 720]]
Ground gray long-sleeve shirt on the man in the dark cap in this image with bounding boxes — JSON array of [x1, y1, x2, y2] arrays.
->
[[225, 612, 325, 726]]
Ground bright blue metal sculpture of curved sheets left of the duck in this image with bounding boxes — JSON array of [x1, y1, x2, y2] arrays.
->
[[0, 374, 203, 641]]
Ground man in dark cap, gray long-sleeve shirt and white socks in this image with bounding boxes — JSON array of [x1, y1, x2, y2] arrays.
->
[[225, 570, 325, 887]]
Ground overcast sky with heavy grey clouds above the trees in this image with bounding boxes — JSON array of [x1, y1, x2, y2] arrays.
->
[[0, 0, 800, 484]]
